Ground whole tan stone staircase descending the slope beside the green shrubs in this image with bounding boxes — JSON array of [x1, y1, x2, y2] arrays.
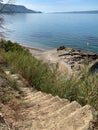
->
[[6, 72, 93, 130]]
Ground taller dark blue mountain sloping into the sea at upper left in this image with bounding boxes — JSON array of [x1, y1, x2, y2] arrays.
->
[[0, 3, 42, 13]]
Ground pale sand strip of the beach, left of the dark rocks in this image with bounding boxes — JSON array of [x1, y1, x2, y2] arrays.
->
[[24, 47, 72, 74]]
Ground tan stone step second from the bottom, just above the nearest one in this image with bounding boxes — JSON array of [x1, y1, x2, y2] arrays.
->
[[33, 101, 81, 130]]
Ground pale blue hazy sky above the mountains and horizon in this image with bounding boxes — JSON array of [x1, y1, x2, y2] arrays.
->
[[16, 0, 98, 12]]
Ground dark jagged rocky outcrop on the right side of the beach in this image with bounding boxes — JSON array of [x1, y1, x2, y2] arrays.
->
[[57, 48, 98, 71]]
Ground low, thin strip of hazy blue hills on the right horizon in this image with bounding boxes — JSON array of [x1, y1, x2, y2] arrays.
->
[[54, 10, 98, 14]]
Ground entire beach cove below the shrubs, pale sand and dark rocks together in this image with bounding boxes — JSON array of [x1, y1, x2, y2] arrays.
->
[[23, 46, 98, 74]]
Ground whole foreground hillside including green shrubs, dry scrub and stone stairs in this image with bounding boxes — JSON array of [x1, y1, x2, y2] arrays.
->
[[0, 40, 98, 130]]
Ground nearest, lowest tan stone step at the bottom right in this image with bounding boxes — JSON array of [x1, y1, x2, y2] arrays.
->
[[49, 105, 93, 130]]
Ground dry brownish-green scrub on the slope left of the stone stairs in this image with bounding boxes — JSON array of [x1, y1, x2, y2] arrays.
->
[[0, 66, 21, 109]]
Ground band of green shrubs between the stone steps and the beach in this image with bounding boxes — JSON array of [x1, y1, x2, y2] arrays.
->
[[0, 40, 98, 111]]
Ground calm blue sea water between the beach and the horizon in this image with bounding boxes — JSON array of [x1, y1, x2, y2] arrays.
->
[[4, 14, 98, 53]]
